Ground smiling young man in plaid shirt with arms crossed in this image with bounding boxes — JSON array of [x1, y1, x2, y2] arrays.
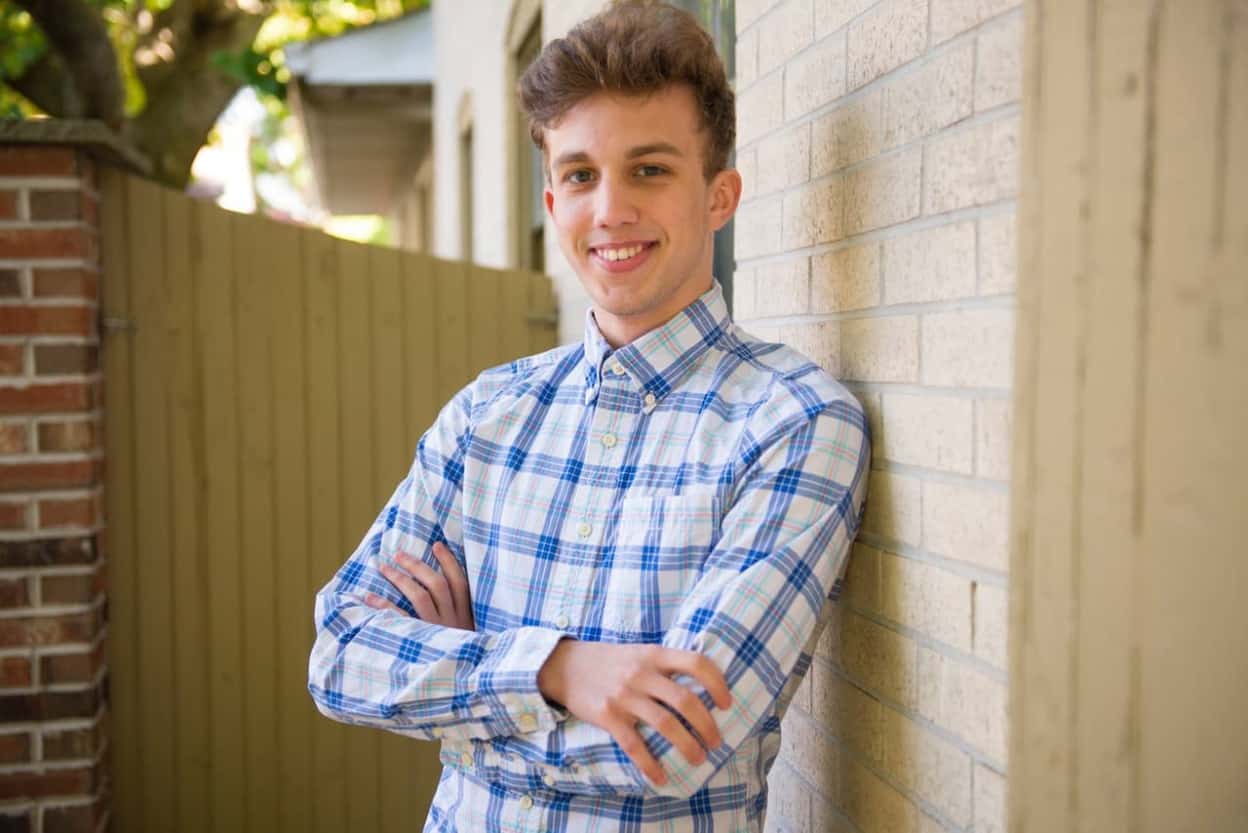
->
[[308, 2, 869, 833]]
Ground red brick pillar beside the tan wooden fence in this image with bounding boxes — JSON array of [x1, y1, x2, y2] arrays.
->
[[0, 145, 107, 833]]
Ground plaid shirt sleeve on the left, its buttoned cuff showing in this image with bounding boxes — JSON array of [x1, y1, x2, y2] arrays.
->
[[308, 388, 567, 739]]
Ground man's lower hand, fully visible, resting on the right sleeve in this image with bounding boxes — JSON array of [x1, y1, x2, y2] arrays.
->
[[538, 638, 733, 787]]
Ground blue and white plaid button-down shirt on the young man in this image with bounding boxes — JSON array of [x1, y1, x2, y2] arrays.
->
[[308, 285, 870, 833]]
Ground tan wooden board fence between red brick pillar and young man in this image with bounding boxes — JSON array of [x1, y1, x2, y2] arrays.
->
[[101, 170, 559, 833]]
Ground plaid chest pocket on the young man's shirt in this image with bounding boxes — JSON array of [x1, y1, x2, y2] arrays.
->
[[597, 493, 720, 643]]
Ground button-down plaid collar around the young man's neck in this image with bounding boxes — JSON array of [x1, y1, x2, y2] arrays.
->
[[584, 280, 731, 402]]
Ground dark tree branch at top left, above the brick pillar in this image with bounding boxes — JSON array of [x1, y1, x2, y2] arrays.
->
[[15, 0, 125, 129]]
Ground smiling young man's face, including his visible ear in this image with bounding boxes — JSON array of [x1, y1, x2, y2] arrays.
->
[[545, 85, 741, 347]]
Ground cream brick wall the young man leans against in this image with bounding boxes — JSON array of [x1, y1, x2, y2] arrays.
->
[[734, 0, 1022, 833]]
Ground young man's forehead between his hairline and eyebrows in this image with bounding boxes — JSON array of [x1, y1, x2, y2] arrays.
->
[[544, 85, 703, 160]]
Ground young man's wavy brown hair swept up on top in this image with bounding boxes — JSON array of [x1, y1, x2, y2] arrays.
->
[[517, 0, 736, 180]]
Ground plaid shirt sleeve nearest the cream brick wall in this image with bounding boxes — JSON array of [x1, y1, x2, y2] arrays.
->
[[471, 402, 870, 798]]
